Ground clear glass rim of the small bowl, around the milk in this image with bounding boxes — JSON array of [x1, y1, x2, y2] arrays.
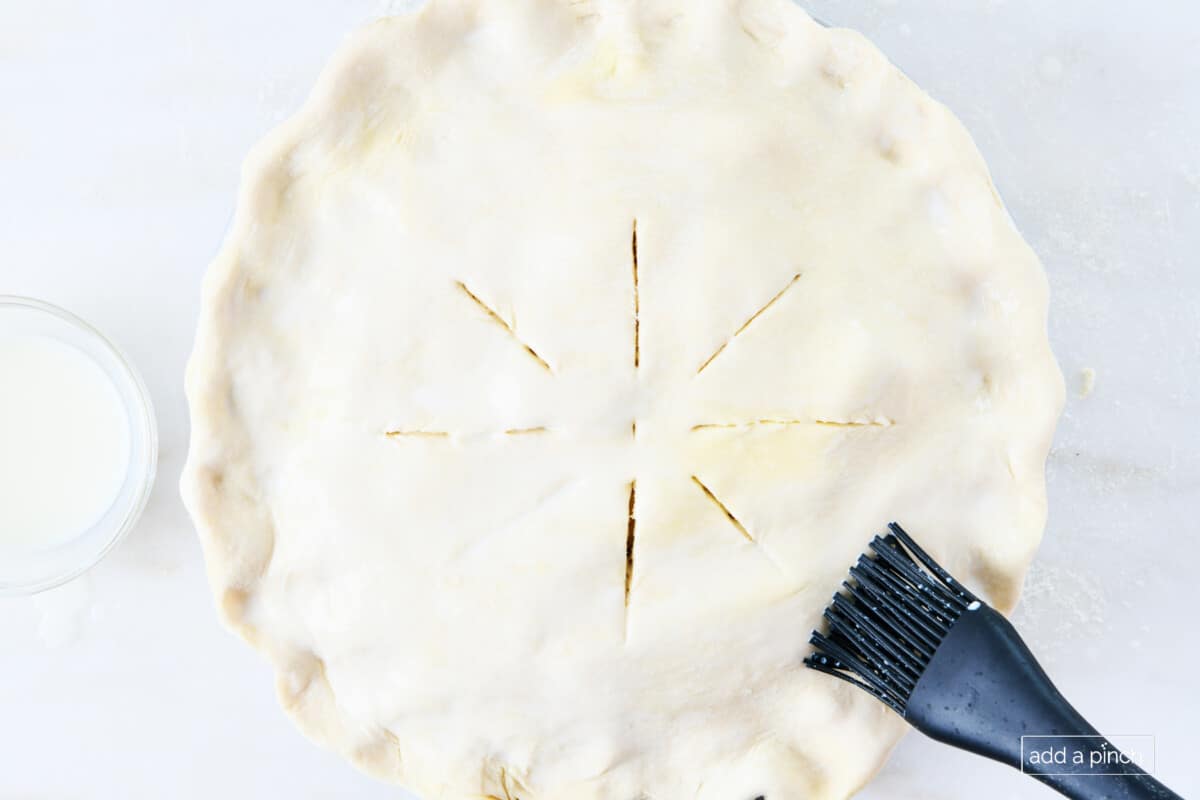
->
[[0, 295, 158, 596]]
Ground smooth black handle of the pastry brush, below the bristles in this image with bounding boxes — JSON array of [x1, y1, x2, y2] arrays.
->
[[904, 603, 1182, 800]]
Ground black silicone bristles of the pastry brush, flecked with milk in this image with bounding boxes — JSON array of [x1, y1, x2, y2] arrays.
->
[[804, 523, 978, 715]]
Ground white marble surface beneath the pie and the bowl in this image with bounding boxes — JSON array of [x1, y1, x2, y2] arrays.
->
[[0, 0, 1200, 800]]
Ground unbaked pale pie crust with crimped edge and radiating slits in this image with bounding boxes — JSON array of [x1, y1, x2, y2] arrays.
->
[[184, 0, 1063, 800]]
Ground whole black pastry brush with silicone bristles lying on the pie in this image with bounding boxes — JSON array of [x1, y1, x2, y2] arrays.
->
[[804, 523, 1180, 800]]
